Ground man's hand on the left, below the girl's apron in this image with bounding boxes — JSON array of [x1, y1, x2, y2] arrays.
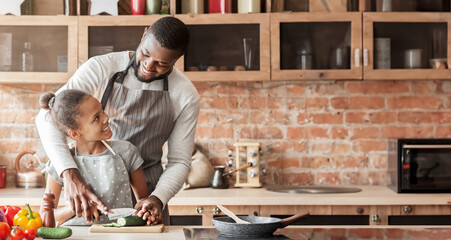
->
[[62, 168, 108, 222]]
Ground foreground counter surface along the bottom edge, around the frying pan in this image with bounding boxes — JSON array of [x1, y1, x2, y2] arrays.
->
[[60, 226, 451, 240]]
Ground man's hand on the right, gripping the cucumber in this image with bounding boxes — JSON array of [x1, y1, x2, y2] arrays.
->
[[135, 195, 163, 225]]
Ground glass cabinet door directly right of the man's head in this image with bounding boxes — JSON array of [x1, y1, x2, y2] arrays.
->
[[176, 13, 269, 81]]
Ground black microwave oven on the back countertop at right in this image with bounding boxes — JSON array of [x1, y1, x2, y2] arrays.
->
[[389, 139, 451, 193]]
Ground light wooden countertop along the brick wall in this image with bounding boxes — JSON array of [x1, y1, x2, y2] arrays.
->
[[0, 186, 451, 206]]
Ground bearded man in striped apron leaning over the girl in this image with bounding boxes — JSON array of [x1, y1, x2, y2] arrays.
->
[[36, 17, 200, 224]]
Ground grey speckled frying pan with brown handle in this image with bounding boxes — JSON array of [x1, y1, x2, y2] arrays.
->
[[213, 211, 310, 237]]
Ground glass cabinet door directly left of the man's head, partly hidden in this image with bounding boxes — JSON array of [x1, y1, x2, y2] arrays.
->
[[78, 15, 163, 66]]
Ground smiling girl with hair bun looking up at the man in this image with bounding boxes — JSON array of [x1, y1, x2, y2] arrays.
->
[[39, 90, 150, 225]]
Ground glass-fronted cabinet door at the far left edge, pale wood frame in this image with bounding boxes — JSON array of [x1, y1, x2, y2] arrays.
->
[[0, 16, 77, 83]]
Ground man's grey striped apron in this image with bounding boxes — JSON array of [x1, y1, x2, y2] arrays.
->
[[101, 55, 174, 225]]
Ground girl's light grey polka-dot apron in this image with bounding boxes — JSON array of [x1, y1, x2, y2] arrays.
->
[[63, 143, 133, 226]]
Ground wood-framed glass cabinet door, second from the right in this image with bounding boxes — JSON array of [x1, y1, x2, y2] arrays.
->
[[271, 13, 362, 80]]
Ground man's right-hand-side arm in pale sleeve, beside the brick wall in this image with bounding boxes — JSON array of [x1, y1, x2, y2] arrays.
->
[[151, 98, 200, 208]]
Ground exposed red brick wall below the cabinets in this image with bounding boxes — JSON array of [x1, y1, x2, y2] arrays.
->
[[0, 81, 451, 188]]
